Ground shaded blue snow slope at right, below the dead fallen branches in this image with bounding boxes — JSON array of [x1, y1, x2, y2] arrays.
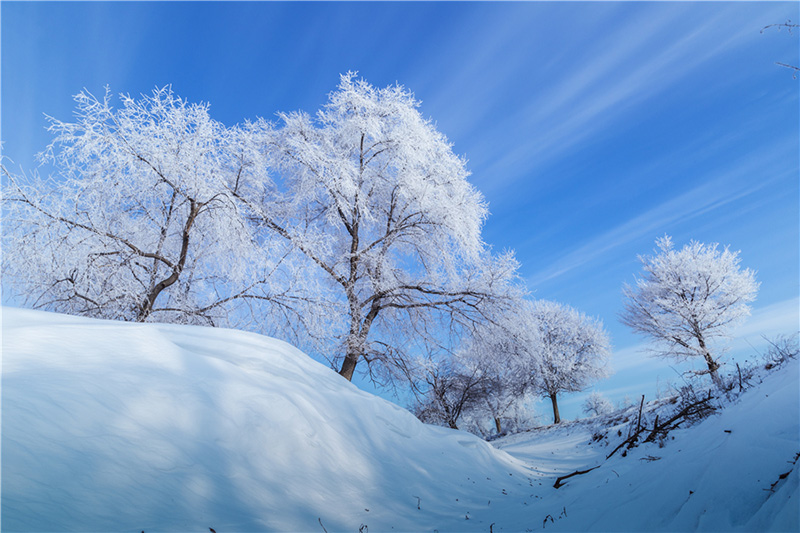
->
[[496, 360, 800, 532]]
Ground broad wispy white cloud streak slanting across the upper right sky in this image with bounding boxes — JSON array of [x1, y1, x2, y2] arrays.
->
[[462, 1, 785, 193]]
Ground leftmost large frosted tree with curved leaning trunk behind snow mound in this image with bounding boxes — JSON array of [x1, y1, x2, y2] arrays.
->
[[3, 87, 296, 325]]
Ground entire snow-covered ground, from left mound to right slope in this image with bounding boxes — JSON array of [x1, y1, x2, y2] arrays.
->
[[1, 308, 800, 533]]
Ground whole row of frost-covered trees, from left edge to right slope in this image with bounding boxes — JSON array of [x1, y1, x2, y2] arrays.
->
[[2, 72, 757, 433]]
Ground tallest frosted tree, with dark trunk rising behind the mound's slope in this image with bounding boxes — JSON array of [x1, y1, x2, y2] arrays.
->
[[240, 73, 517, 380]]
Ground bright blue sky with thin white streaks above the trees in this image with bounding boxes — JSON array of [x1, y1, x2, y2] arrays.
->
[[0, 1, 800, 417]]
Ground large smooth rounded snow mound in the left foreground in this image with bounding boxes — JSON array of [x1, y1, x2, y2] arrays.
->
[[2, 308, 527, 533]]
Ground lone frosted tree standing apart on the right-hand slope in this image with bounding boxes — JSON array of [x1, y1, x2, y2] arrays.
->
[[621, 236, 758, 388]]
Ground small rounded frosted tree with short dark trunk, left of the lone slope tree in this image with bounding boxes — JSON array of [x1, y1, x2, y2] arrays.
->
[[521, 300, 611, 424]]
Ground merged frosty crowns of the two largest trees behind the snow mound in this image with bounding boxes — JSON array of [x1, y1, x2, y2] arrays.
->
[[2, 73, 518, 386]]
